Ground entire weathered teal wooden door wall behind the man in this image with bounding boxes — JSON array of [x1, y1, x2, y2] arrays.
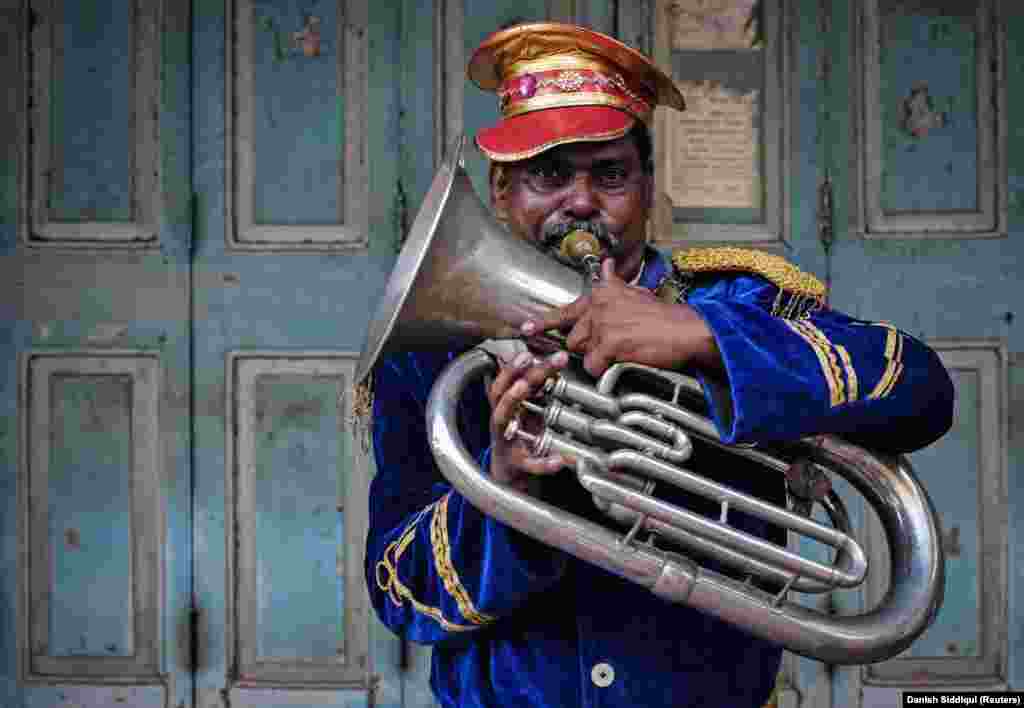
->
[[6, 0, 1024, 708]]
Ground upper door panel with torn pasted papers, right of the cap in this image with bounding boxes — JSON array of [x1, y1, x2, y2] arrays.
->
[[651, 0, 788, 248]]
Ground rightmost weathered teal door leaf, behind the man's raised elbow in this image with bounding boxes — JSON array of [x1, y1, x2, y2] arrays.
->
[[820, 1, 1022, 706]]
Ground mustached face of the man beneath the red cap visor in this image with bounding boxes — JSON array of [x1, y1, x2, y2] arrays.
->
[[492, 136, 653, 278]]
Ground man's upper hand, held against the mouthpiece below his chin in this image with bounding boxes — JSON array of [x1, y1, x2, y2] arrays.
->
[[522, 258, 722, 377]]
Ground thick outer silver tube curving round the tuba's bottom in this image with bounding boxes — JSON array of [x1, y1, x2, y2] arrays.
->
[[426, 348, 944, 664]]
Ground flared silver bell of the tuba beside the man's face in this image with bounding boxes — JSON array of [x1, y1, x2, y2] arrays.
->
[[355, 140, 584, 381]]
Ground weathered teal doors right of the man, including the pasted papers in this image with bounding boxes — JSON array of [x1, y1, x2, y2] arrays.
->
[[620, 0, 1024, 707]]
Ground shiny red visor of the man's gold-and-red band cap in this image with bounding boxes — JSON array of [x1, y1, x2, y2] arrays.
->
[[476, 106, 636, 162]]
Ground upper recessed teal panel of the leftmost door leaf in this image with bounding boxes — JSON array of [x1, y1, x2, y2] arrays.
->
[[49, 0, 135, 221]]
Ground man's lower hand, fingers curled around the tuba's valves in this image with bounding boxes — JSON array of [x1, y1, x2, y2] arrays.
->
[[487, 351, 568, 492]]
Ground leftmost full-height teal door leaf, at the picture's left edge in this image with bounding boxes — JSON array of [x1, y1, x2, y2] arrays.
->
[[0, 0, 191, 707]]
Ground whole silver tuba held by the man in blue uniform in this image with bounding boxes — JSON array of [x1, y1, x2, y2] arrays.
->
[[356, 140, 944, 664]]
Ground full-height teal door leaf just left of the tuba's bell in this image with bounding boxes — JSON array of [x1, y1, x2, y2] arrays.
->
[[193, 0, 399, 707]]
